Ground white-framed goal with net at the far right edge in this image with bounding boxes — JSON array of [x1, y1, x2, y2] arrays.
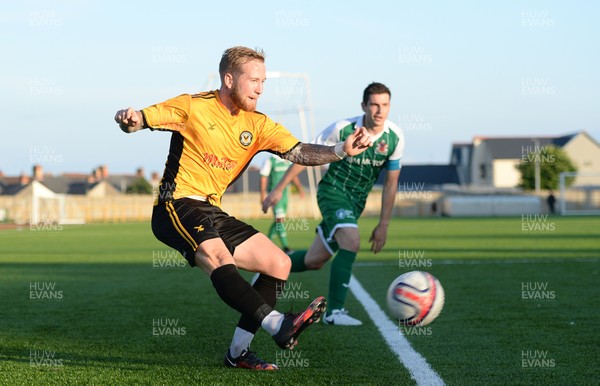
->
[[559, 172, 600, 215]]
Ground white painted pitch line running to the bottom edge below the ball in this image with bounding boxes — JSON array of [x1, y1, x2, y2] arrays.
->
[[349, 275, 444, 386]]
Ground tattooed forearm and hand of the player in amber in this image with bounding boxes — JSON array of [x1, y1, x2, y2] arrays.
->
[[281, 127, 373, 166]]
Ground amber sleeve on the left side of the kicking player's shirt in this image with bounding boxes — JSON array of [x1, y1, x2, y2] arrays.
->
[[142, 94, 192, 131]]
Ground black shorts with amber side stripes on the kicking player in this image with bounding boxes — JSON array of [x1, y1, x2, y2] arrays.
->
[[152, 198, 258, 267]]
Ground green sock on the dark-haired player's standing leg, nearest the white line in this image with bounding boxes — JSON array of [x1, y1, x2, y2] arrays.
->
[[327, 249, 356, 315]]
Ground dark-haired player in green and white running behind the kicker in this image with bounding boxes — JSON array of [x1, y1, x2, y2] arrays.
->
[[263, 83, 404, 326]]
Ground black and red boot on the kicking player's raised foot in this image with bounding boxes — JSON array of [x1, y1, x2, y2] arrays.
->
[[273, 296, 327, 349]]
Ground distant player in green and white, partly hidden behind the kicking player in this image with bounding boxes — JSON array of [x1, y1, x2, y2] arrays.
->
[[260, 155, 304, 253]]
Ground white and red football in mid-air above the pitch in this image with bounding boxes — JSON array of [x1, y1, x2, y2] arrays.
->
[[387, 271, 444, 326]]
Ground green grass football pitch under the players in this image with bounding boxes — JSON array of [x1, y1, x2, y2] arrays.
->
[[0, 217, 600, 385]]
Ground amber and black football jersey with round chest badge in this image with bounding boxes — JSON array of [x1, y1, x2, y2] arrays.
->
[[142, 90, 300, 206]]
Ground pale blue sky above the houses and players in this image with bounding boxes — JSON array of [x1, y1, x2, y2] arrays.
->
[[0, 0, 600, 175]]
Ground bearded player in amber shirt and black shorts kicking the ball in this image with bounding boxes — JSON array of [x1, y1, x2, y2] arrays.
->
[[115, 47, 371, 370]]
